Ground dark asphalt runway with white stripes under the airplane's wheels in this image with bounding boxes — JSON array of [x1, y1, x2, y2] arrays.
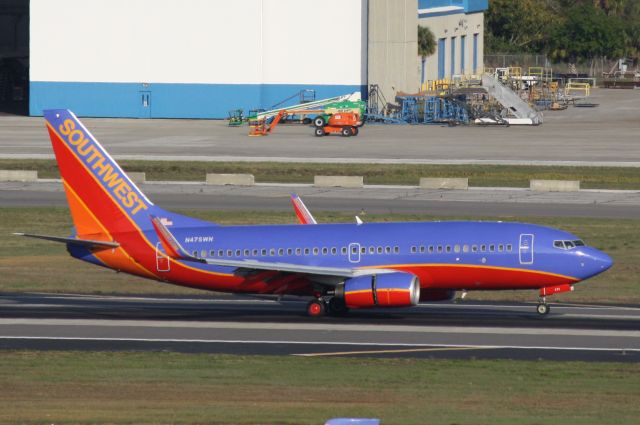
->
[[0, 294, 640, 362]]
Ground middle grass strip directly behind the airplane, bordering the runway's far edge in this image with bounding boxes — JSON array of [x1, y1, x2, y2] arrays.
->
[[0, 208, 640, 304]]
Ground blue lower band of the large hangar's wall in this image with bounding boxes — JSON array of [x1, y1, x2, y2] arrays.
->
[[29, 81, 367, 118]]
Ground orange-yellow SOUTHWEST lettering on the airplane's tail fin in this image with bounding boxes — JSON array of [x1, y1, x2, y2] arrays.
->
[[58, 114, 149, 215]]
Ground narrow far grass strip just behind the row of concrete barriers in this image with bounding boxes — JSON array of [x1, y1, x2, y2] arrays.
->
[[0, 159, 640, 190]]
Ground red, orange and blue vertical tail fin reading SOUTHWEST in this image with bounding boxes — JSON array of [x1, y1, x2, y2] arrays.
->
[[44, 109, 158, 235]]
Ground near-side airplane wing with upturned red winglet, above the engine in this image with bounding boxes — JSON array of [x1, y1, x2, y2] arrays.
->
[[151, 216, 394, 278]]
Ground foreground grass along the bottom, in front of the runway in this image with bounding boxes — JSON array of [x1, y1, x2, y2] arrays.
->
[[0, 352, 640, 425]]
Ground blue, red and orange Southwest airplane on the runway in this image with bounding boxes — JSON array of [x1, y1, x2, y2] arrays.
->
[[21, 109, 612, 317]]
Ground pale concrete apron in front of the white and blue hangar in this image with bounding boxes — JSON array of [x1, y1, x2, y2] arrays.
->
[[0, 89, 640, 163]]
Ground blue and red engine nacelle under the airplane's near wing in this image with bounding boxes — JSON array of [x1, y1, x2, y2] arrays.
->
[[336, 272, 420, 308]]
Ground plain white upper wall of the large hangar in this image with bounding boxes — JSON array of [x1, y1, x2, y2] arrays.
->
[[30, 0, 366, 85]]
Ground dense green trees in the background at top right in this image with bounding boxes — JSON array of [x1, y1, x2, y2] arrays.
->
[[485, 0, 640, 63]]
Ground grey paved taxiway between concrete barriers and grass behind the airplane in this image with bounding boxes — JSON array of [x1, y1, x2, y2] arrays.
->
[[0, 182, 640, 219]]
